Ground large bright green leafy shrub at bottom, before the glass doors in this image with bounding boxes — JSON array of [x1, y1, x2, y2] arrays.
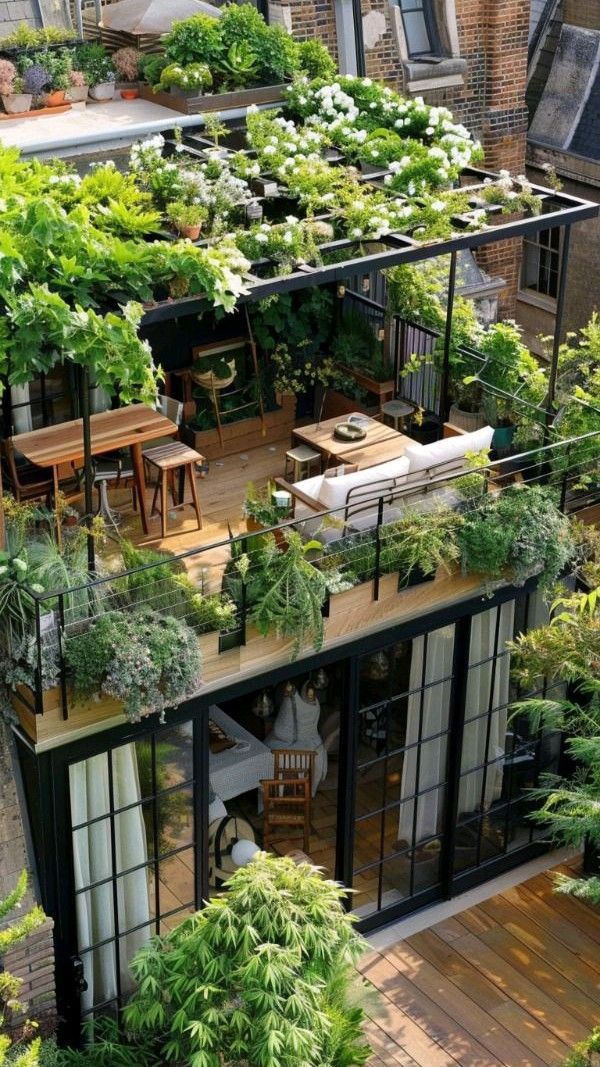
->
[[74, 854, 370, 1067]]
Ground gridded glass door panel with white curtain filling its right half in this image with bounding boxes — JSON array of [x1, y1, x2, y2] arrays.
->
[[352, 625, 454, 923]]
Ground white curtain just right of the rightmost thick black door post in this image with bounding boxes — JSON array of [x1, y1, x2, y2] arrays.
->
[[458, 601, 515, 815]]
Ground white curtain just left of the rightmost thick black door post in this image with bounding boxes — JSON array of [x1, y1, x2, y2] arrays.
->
[[398, 625, 454, 844]]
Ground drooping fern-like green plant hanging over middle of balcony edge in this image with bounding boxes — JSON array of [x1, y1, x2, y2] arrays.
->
[[248, 530, 327, 657]]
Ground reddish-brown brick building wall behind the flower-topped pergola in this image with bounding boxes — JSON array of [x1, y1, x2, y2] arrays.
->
[[269, 0, 530, 316]]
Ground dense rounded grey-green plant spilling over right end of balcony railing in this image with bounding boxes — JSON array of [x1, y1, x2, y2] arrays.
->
[[458, 485, 574, 589]]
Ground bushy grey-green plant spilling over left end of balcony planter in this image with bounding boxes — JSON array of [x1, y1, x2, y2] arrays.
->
[[64, 609, 202, 722]]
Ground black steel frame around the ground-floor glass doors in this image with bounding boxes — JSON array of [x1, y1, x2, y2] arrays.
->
[[13, 579, 559, 1040]]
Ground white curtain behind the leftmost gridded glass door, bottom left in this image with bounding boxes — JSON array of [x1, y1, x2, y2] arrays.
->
[[69, 745, 151, 1010]]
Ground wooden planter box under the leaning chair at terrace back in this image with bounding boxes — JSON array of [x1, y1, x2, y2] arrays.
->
[[183, 396, 296, 460]]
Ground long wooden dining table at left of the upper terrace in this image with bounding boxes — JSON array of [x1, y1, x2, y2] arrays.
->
[[15, 403, 177, 534]]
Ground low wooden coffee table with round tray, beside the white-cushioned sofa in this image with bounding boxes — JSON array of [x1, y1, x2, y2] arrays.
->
[[291, 412, 413, 469]]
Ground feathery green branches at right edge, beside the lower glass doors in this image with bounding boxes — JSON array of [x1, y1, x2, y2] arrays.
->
[[509, 588, 600, 905]]
